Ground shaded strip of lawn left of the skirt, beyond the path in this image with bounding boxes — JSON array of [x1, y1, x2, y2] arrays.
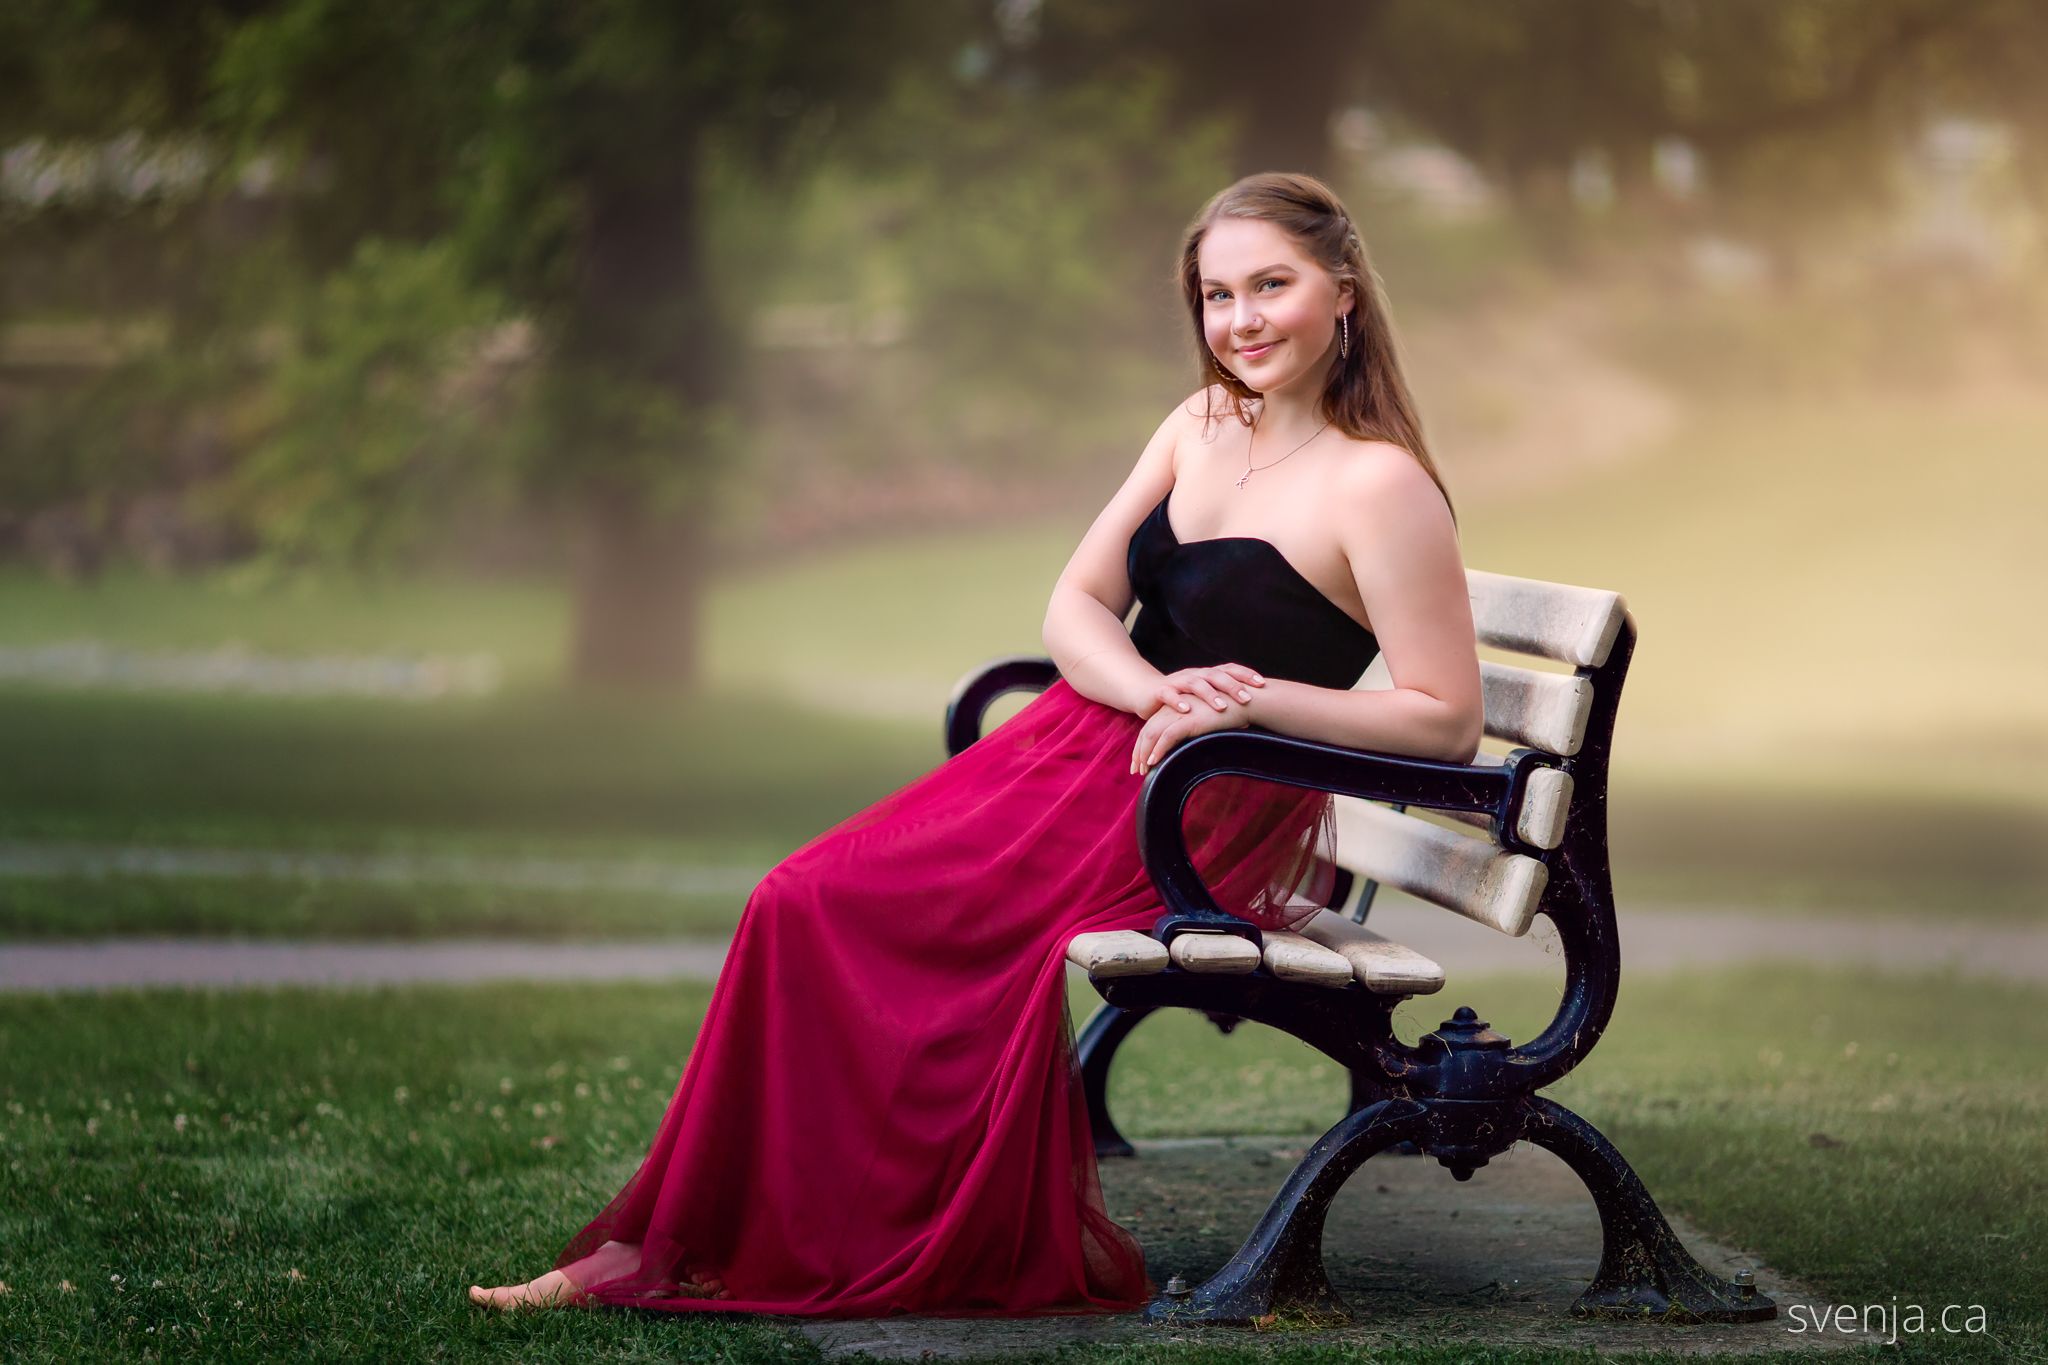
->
[[0, 692, 940, 851]]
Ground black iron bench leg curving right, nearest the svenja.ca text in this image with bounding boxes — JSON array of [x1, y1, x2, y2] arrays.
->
[[1524, 1095, 1778, 1322]]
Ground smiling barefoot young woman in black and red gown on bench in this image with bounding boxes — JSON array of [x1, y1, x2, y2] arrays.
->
[[471, 174, 1481, 1316]]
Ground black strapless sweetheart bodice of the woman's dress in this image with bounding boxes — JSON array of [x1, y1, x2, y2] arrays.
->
[[1126, 493, 1380, 688]]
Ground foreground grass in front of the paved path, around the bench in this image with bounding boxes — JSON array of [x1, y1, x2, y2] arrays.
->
[[0, 970, 2048, 1361]]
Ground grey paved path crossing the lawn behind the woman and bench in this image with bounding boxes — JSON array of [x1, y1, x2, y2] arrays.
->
[[0, 898, 2048, 990]]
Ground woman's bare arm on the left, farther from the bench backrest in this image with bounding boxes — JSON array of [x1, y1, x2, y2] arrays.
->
[[1040, 397, 1182, 716]]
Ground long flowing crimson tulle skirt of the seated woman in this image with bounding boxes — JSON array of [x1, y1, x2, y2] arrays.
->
[[555, 679, 1329, 1318]]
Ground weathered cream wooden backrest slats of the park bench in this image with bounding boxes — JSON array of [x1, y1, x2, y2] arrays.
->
[[1323, 569, 1628, 935]]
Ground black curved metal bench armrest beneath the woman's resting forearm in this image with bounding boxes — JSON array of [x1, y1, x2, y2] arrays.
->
[[1137, 726, 1550, 943]]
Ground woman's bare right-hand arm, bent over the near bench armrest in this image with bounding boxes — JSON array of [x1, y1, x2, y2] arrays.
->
[[1196, 446, 1485, 763]]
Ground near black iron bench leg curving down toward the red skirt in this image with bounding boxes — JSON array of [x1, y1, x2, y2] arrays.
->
[[1145, 1099, 1427, 1326]]
